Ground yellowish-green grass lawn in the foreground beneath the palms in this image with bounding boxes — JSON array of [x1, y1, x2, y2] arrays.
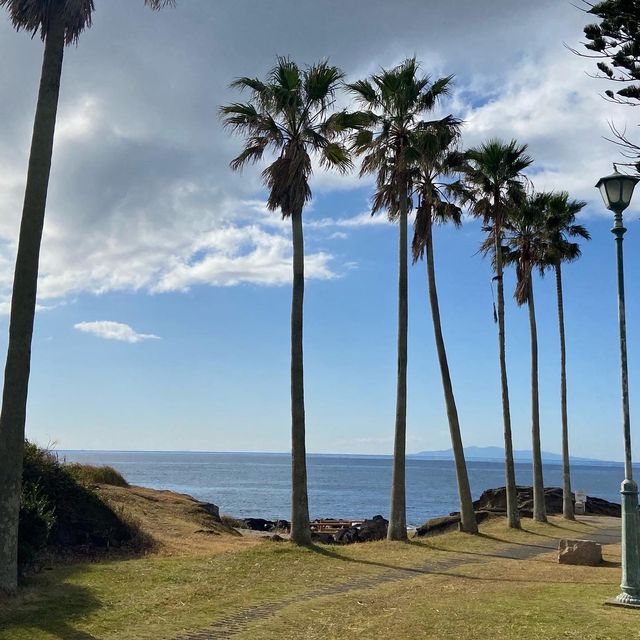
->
[[0, 504, 640, 640]]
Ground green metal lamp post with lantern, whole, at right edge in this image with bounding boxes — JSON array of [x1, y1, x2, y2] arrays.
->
[[596, 164, 640, 606]]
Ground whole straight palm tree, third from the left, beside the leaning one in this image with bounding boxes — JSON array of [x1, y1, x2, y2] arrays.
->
[[347, 58, 451, 540]]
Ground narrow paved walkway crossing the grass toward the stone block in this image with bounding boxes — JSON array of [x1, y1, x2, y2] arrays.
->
[[176, 516, 620, 640]]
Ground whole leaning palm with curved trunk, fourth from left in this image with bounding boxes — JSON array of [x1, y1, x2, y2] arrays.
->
[[412, 127, 478, 533]]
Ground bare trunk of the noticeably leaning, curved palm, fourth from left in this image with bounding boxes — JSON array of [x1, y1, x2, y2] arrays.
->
[[425, 220, 478, 533]]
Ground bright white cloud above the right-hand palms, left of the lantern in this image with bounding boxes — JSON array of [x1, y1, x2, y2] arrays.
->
[[456, 50, 635, 215]]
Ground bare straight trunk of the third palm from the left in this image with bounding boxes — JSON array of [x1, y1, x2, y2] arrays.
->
[[387, 188, 408, 540]]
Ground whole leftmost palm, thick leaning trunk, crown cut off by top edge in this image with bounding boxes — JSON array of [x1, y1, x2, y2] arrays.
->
[[0, 0, 173, 593]]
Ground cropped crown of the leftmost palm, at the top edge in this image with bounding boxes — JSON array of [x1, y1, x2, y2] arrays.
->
[[0, 0, 175, 44]]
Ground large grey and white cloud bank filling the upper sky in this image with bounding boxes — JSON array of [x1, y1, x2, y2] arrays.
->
[[0, 0, 632, 310]]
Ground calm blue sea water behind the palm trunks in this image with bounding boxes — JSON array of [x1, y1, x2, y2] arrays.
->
[[60, 451, 623, 526]]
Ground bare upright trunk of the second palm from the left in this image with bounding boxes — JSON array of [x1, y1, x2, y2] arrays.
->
[[291, 211, 311, 544]]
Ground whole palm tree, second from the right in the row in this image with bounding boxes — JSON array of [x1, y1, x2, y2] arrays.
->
[[505, 193, 548, 522]]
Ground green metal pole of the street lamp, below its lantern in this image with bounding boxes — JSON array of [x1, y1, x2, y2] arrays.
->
[[611, 207, 640, 606]]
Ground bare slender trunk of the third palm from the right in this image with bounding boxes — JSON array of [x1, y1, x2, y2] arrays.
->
[[494, 224, 520, 529]]
